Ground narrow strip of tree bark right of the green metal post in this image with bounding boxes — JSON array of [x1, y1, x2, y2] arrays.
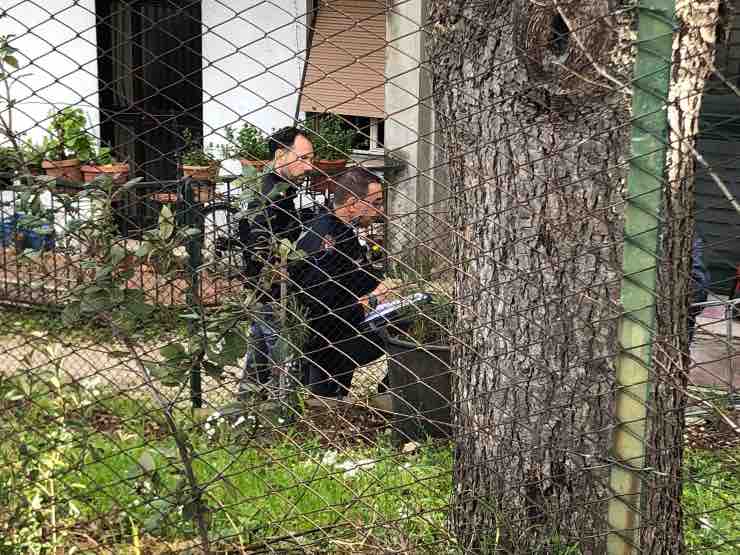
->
[[640, 0, 720, 554]]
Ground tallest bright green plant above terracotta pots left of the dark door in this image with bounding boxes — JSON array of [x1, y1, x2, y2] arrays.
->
[[43, 107, 97, 162]]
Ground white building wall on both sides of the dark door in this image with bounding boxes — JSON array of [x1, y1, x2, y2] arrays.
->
[[0, 0, 307, 168]]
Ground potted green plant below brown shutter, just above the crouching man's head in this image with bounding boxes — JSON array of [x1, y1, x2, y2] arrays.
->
[[310, 114, 356, 192]]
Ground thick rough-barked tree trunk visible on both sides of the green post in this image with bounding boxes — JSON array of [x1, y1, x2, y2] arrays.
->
[[429, 0, 718, 553]]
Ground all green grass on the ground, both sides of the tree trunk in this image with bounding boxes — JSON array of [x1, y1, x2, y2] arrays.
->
[[0, 383, 740, 555]]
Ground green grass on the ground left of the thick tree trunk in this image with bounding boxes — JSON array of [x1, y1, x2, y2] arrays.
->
[[0, 388, 452, 551]]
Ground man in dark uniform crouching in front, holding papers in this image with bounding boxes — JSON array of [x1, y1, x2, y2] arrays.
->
[[290, 168, 383, 398]]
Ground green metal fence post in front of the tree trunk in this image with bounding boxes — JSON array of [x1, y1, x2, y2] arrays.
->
[[607, 0, 674, 555]]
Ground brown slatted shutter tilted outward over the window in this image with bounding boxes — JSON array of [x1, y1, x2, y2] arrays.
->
[[300, 0, 386, 118]]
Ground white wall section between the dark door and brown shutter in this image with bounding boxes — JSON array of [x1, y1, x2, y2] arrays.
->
[[203, 0, 306, 148]]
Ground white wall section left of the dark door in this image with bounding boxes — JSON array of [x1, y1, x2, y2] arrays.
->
[[0, 0, 99, 146]]
